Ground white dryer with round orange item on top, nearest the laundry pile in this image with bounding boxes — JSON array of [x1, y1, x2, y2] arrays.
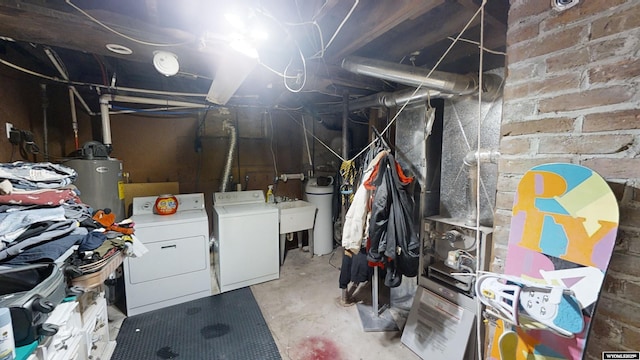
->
[[123, 193, 211, 316]]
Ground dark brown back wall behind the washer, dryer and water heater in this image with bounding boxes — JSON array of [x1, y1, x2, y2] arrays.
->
[[0, 67, 332, 212]]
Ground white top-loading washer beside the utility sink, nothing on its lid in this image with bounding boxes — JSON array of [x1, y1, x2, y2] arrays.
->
[[213, 190, 280, 292]]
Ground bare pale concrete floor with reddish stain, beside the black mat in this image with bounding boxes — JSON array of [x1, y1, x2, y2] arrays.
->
[[109, 248, 420, 360]]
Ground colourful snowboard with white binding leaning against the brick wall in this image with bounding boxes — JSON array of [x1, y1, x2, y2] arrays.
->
[[477, 163, 619, 360]]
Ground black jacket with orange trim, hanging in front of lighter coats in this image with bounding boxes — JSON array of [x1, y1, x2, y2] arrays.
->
[[366, 154, 420, 287]]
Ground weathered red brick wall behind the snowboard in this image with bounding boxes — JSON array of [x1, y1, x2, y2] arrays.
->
[[500, 0, 640, 359]]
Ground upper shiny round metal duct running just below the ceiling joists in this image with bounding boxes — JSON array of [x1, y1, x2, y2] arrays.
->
[[342, 56, 478, 95]]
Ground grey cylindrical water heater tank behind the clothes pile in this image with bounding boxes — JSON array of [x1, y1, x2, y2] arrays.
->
[[65, 158, 126, 222]]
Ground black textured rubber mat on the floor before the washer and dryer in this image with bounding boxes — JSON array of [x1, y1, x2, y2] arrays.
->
[[111, 287, 281, 360]]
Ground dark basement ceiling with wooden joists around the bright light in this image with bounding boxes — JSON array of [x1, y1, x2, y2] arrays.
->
[[0, 0, 509, 112]]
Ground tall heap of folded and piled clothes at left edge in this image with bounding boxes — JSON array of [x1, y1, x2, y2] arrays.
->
[[0, 161, 133, 266]]
